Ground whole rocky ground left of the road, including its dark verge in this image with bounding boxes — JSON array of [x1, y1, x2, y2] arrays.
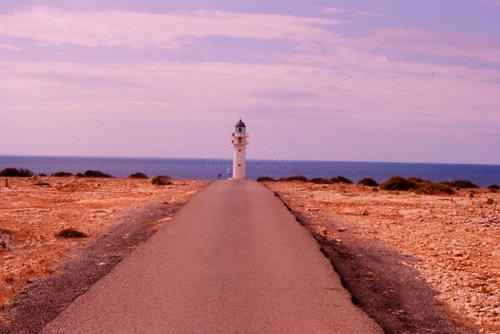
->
[[0, 178, 206, 333]]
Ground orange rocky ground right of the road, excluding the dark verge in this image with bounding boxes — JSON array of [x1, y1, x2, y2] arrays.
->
[[266, 182, 500, 333]]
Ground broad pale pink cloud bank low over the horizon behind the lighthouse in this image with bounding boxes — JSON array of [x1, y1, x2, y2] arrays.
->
[[0, 56, 500, 161]]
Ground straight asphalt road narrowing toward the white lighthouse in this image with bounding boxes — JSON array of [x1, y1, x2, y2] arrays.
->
[[43, 181, 382, 334]]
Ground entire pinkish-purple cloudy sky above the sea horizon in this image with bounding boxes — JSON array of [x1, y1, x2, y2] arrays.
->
[[0, 0, 500, 164]]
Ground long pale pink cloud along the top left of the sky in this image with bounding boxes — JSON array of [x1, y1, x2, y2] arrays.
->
[[0, 7, 339, 48]]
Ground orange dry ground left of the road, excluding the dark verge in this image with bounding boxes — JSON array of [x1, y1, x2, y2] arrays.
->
[[0, 177, 206, 306]]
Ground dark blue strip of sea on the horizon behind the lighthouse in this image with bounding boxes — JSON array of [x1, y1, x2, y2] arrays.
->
[[0, 156, 500, 186]]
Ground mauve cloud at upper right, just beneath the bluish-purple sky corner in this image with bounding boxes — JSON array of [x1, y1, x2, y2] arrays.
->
[[286, 28, 500, 69]]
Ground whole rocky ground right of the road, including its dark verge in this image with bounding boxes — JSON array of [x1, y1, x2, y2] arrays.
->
[[266, 182, 500, 333]]
